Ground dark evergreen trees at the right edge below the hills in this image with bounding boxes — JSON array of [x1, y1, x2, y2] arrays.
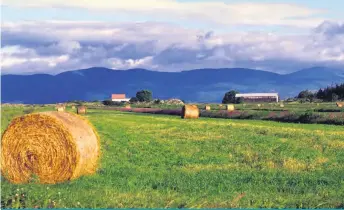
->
[[296, 83, 344, 102]]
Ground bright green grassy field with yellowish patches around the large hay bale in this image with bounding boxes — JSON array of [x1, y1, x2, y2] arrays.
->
[[1, 108, 344, 208]]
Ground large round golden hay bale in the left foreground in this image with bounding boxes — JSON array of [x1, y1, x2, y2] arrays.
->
[[1, 111, 100, 184]]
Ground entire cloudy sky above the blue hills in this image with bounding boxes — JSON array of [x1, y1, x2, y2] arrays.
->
[[1, 0, 344, 74]]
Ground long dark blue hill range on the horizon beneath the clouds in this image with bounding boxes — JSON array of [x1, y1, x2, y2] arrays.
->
[[1, 67, 344, 104]]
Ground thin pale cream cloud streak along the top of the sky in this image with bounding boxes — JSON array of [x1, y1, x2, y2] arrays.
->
[[3, 0, 326, 27]]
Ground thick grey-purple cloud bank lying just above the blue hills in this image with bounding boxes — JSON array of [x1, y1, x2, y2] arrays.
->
[[1, 21, 344, 74]]
